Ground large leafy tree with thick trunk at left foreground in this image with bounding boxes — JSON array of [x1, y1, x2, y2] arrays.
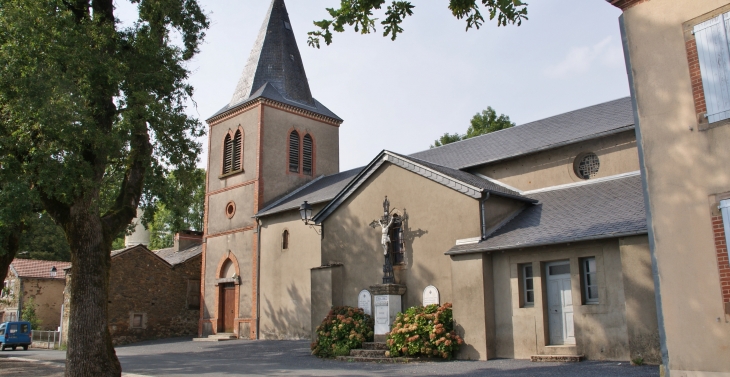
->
[[0, 0, 208, 376]]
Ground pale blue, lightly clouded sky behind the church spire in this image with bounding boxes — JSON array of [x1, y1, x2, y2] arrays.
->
[[115, 0, 629, 171]]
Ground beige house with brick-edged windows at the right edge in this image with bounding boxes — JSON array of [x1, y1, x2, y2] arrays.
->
[[609, 0, 730, 377]]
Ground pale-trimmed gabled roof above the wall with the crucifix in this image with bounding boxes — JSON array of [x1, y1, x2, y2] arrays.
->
[[313, 150, 537, 224]]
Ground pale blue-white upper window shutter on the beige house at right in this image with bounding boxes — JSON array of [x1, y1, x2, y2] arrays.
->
[[694, 14, 730, 123]]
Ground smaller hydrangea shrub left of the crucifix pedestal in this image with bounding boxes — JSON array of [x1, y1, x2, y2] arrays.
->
[[311, 306, 375, 357]]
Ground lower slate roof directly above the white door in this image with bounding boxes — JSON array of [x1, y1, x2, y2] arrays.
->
[[446, 172, 647, 254]]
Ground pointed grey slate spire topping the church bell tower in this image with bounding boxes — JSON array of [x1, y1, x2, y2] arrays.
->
[[229, 0, 315, 107]]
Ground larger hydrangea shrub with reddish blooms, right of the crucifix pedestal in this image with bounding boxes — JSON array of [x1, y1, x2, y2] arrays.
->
[[387, 303, 464, 359]]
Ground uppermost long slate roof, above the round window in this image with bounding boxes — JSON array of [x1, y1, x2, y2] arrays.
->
[[410, 97, 634, 169]]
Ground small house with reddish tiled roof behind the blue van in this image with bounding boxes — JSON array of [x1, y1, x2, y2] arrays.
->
[[0, 258, 70, 331]]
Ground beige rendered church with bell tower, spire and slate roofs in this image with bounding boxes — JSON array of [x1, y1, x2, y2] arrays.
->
[[198, 0, 661, 363]]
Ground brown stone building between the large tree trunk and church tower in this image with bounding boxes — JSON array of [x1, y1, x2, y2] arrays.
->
[[64, 231, 202, 345]]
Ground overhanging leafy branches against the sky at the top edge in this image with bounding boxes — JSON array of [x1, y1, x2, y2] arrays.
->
[[307, 0, 527, 48]]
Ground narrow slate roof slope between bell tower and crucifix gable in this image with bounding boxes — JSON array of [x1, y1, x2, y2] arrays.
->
[[256, 167, 363, 217]]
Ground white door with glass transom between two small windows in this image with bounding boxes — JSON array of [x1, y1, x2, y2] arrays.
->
[[546, 261, 575, 344]]
